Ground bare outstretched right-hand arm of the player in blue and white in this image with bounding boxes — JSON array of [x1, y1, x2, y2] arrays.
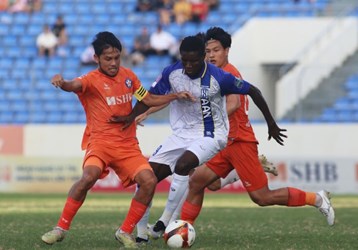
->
[[248, 85, 287, 146]]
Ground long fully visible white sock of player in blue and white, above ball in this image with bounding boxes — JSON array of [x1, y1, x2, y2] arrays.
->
[[159, 173, 189, 226]]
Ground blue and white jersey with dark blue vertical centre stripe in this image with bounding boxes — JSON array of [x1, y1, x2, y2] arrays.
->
[[149, 62, 250, 138]]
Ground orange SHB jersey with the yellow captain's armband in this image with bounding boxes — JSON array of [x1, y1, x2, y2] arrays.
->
[[77, 67, 147, 149]]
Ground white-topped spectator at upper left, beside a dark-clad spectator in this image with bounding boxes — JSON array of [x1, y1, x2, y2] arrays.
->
[[36, 24, 57, 57]]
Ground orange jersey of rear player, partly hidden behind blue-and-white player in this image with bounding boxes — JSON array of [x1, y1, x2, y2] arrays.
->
[[223, 63, 258, 143]]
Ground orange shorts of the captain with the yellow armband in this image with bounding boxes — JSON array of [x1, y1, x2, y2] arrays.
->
[[83, 142, 152, 187]]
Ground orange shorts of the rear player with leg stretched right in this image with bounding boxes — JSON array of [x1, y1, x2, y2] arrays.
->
[[206, 141, 268, 192]]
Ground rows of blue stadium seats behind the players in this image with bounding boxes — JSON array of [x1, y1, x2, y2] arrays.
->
[[0, 0, 340, 124]]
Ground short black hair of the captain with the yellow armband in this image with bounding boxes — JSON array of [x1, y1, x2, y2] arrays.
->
[[92, 31, 122, 56]]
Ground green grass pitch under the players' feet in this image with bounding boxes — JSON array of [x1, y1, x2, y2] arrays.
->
[[0, 193, 358, 250]]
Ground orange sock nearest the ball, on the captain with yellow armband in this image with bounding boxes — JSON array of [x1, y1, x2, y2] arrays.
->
[[121, 199, 148, 234]]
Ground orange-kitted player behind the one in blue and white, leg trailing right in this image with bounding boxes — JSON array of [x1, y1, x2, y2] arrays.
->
[[181, 27, 335, 229]]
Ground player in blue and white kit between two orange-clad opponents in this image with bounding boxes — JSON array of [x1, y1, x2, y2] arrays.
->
[[112, 36, 286, 240]]
